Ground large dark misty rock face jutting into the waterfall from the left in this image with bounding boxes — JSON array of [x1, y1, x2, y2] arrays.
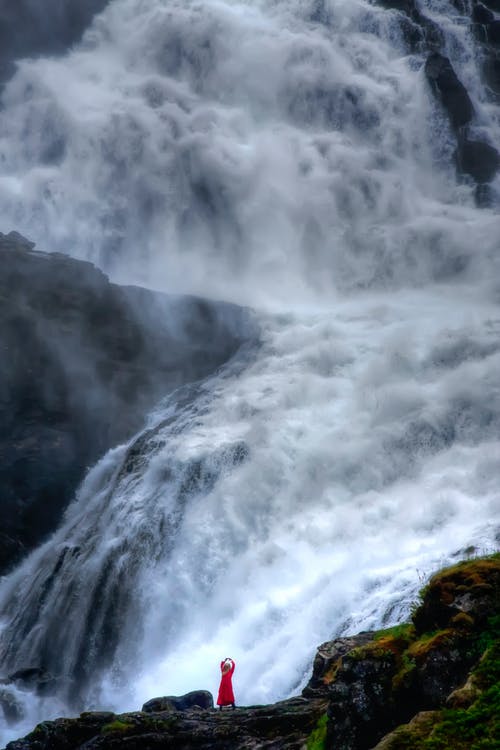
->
[[0, 233, 255, 574]]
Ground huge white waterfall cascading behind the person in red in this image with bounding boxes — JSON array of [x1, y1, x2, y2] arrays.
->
[[0, 0, 500, 739]]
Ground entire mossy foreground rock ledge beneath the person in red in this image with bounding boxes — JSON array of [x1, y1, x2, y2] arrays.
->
[[2, 554, 500, 750]]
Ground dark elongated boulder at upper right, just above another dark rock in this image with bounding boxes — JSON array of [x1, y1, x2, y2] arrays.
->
[[425, 52, 474, 129]]
